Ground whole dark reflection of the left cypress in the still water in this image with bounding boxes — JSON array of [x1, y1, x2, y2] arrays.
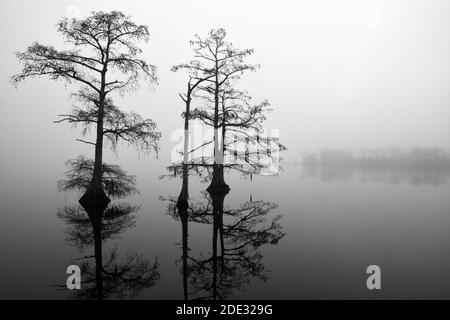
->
[[58, 203, 159, 299]]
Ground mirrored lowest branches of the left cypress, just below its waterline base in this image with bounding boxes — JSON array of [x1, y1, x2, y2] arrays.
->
[[57, 203, 139, 249]]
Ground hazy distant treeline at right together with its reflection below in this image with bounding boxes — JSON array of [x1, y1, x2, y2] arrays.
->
[[302, 148, 450, 186]]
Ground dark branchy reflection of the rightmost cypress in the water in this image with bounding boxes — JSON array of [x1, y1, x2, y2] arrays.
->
[[185, 198, 285, 299]]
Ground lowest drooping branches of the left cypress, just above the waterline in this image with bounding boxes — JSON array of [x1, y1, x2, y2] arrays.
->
[[58, 156, 139, 198]]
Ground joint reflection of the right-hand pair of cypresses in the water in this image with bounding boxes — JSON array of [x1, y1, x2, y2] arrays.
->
[[161, 167, 285, 299]]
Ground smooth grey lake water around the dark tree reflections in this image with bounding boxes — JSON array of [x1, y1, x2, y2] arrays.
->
[[0, 164, 450, 299]]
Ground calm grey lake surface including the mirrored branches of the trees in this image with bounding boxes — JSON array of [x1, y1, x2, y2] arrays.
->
[[1, 164, 450, 299]]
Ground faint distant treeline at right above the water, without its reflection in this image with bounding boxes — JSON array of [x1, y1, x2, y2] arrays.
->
[[302, 147, 450, 168]]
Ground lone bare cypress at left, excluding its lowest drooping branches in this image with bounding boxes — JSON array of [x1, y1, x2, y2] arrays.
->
[[12, 11, 160, 198]]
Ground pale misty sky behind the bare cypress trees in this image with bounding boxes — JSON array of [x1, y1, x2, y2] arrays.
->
[[0, 0, 450, 169]]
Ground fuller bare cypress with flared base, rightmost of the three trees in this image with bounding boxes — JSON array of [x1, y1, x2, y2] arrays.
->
[[175, 29, 286, 180]]
